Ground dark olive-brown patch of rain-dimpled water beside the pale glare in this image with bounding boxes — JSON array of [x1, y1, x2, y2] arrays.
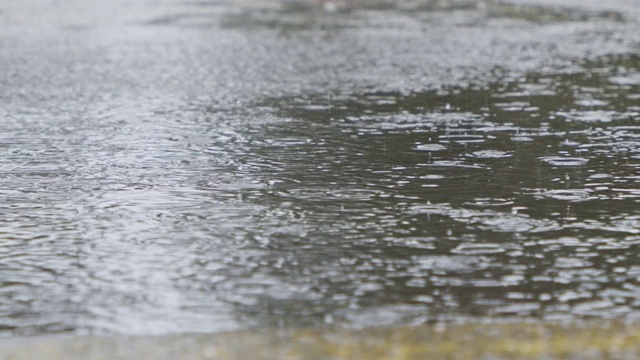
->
[[256, 52, 640, 322]]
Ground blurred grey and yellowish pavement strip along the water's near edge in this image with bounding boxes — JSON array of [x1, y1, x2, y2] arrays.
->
[[0, 321, 640, 360]]
